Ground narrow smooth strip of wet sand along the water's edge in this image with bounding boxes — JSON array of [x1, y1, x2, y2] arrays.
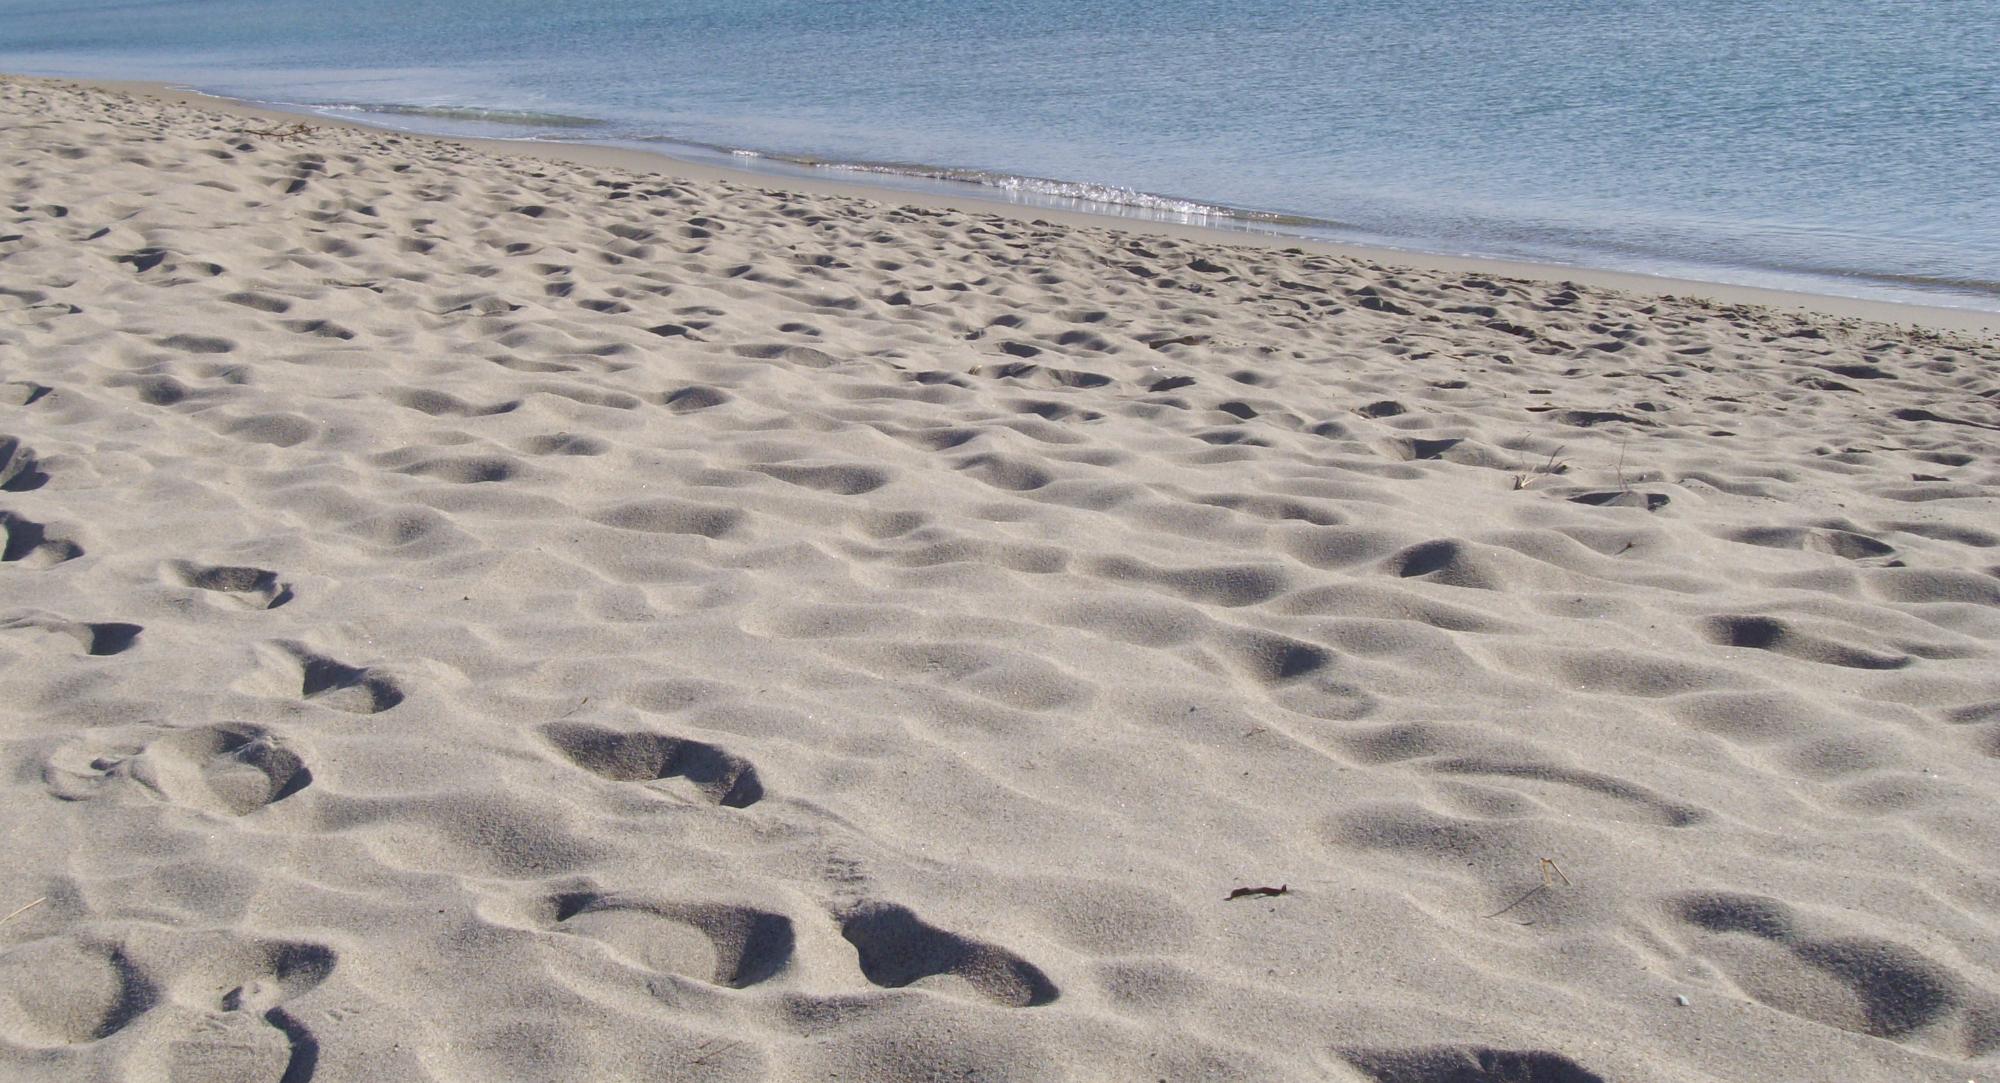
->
[[54, 74, 2000, 334]]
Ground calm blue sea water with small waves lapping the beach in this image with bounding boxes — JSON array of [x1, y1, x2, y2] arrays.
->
[[0, 0, 2000, 310]]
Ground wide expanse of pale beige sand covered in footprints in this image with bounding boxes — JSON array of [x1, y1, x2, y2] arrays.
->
[[0, 80, 2000, 1083]]
